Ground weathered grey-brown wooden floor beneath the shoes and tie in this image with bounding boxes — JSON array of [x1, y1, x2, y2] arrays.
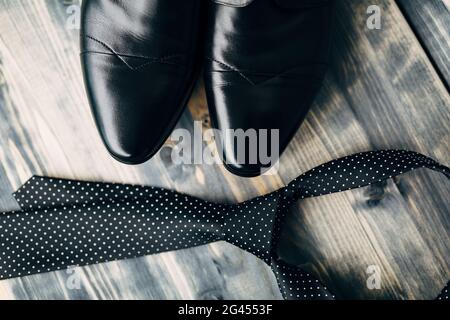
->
[[0, 0, 450, 299]]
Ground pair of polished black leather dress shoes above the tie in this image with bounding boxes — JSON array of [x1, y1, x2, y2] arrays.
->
[[81, 0, 333, 177]]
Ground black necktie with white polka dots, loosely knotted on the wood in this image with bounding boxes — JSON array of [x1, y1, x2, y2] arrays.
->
[[0, 150, 450, 300]]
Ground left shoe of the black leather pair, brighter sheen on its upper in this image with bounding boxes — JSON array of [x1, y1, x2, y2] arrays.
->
[[81, 0, 203, 164]]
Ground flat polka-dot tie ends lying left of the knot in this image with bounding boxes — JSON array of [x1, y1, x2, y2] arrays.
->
[[0, 177, 225, 278]]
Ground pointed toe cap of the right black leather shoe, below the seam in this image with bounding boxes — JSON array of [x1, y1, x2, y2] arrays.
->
[[206, 66, 321, 177]]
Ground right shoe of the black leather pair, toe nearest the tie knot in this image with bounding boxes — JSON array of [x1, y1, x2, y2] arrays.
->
[[204, 0, 333, 177]]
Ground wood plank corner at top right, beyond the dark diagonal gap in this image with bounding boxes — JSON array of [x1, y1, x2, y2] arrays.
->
[[397, 0, 450, 89]]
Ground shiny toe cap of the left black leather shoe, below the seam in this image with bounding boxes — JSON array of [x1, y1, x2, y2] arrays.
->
[[83, 54, 189, 164]]
